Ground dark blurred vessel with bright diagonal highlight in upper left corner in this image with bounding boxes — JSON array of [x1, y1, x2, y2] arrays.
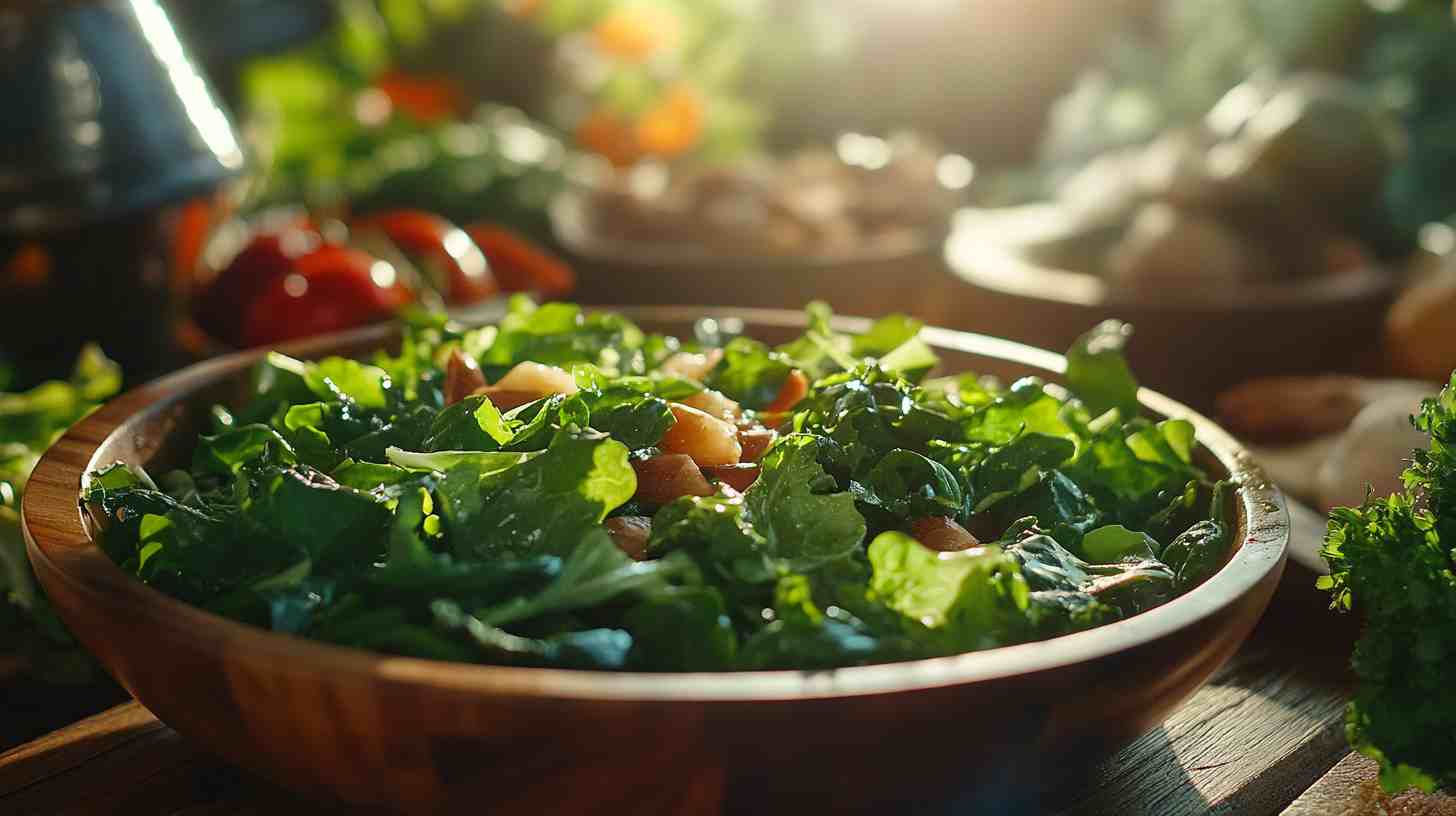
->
[[0, 0, 243, 382]]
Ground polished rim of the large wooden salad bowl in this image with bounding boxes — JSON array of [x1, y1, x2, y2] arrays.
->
[[22, 306, 1289, 702]]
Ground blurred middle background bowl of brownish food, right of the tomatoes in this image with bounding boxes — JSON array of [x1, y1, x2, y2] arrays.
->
[[552, 134, 974, 319]]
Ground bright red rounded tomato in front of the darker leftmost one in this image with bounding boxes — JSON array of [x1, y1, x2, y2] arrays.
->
[[239, 245, 414, 345]]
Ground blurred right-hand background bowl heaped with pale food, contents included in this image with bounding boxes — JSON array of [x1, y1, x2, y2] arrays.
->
[[946, 76, 1401, 407]]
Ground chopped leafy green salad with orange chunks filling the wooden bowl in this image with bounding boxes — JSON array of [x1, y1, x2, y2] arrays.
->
[[84, 299, 1232, 672]]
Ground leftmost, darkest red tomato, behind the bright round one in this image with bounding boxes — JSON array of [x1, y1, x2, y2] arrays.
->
[[195, 217, 323, 345]]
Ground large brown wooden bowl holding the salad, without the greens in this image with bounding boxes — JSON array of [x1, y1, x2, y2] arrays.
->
[[23, 307, 1289, 815]]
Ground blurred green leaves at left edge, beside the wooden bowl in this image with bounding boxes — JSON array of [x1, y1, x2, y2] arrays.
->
[[0, 345, 121, 682]]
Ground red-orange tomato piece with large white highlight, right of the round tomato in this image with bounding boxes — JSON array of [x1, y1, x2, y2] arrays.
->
[[355, 210, 501, 305]]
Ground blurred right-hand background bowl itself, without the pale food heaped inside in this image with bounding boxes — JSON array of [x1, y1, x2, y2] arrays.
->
[[941, 211, 1401, 409]]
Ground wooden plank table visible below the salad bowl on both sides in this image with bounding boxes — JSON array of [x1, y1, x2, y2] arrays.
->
[[0, 565, 1456, 816]]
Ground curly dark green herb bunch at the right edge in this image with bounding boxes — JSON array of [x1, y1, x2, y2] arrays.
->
[[1319, 376, 1456, 793]]
